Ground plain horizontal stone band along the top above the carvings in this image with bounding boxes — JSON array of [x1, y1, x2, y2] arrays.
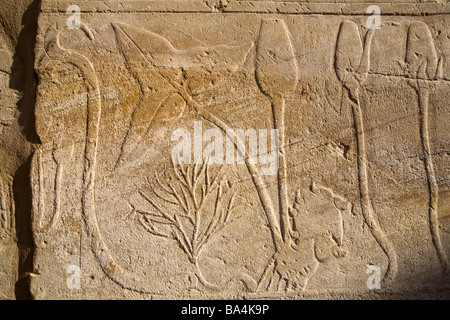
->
[[41, 0, 450, 16]]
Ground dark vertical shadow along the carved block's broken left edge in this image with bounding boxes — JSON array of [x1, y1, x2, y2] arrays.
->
[[10, 0, 40, 300]]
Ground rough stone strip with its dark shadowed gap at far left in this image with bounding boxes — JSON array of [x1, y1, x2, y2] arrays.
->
[[0, 0, 37, 299]]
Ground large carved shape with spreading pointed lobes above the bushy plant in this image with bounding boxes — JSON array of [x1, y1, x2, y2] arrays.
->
[[112, 23, 253, 168]]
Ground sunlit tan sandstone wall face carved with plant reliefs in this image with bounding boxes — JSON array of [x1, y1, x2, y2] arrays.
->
[[0, 0, 450, 299]]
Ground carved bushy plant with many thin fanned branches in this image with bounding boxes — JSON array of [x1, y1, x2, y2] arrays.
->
[[133, 161, 238, 282]]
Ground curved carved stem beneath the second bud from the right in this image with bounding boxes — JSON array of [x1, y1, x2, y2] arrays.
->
[[350, 92, 397, 286]]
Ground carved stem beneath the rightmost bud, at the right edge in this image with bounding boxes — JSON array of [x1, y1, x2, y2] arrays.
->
[[416, 80, 449, 271]]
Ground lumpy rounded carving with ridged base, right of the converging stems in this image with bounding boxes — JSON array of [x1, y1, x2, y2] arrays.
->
[[259, 182, 351, 292]]
